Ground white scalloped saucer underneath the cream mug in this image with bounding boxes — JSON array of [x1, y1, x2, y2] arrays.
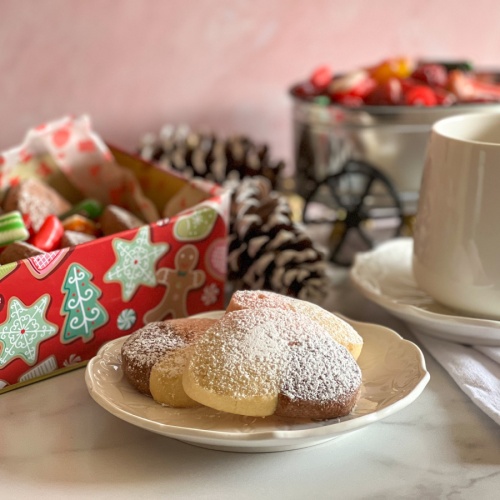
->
[[351, 238, 500, 346]]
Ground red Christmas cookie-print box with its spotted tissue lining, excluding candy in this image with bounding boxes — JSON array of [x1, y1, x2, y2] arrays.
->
[[0, 117, 229, 392]]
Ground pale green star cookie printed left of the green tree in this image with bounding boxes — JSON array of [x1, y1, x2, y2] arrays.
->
[[0, 294, 57, 368]]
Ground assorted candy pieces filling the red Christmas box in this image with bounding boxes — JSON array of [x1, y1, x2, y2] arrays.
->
[[0, 178, 145, 264]]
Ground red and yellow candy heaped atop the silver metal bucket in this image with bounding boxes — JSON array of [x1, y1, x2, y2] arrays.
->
[[292, 57, 500, 107]]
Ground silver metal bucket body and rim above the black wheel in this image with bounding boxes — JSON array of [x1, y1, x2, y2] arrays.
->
[[290, 88, 500, 214]]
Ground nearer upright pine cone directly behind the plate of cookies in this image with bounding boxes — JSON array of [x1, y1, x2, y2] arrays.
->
[[228, 177, 327, 301]]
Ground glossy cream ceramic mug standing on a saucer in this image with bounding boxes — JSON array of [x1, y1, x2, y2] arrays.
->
[[413, 114, 500, 319]]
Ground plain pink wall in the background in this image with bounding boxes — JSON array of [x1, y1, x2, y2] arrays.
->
[[0, 0, 500, 173]]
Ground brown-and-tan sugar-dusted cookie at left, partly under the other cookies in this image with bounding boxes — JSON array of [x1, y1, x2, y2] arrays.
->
[[121, 318, 216, 406]]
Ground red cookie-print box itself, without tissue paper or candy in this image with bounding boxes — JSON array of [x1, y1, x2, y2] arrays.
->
[[0, 118, 229, 392]]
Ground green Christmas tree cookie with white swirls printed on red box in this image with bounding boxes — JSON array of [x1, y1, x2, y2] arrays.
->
[[61, 264, 108, 343]]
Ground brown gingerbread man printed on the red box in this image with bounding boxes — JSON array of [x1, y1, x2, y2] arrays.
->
[[144, 245, 205, 323]]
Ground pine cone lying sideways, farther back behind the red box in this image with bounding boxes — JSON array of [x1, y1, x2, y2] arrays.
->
[[139, 125, 284, 189]]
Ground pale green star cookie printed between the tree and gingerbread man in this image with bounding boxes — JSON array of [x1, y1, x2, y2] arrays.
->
[[104, 226, 170, 302]]
